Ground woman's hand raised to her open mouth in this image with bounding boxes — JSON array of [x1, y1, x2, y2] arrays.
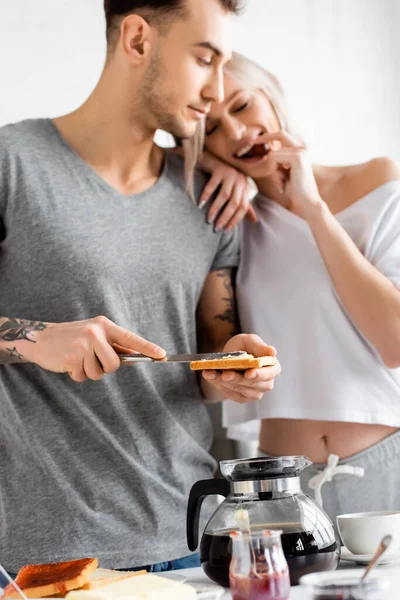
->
[[257, 131, 322, 220]]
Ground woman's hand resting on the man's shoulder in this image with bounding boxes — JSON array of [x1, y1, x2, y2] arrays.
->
[[199, 152, 258, 231]]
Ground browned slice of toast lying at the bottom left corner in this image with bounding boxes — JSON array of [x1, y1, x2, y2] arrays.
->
[[3, 558, 98, 600]]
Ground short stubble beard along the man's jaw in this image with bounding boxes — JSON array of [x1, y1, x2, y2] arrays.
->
[[141, 52, 195, 138]]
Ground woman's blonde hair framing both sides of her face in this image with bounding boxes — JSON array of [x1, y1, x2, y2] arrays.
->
[[182, 52, 301, 199]]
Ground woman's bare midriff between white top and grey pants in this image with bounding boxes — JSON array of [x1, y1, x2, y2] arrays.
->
[[259, 419, 398, 463]]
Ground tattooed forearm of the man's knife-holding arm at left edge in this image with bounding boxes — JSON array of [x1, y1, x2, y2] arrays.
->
[[0, 317, 48, 364]]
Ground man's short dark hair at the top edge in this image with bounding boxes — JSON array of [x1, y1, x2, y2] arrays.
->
[[104, 0, 241, 46]]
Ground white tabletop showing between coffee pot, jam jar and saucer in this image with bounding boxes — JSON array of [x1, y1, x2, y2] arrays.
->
[[173, 562, 400, 600]]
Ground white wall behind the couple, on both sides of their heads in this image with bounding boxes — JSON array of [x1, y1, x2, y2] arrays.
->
[[0, 0, 400, 163]]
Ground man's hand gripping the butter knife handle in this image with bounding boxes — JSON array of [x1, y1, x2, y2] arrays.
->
[[20, 317, 166, 382]]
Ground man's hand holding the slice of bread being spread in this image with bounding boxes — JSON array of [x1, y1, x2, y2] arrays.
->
[[202, 333, 281, 404]]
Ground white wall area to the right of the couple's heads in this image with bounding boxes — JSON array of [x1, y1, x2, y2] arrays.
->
[[231, 0, 400, 164]]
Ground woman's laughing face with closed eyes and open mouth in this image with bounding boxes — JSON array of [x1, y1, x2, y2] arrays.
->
[[205, 75, 280, 179]]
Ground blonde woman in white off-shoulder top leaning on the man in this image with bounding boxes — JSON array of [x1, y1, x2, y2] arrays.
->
[[190, 54, 400, 520]]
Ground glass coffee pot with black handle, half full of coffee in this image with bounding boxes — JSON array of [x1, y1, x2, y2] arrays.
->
[[187, 456, 340, 587]]
